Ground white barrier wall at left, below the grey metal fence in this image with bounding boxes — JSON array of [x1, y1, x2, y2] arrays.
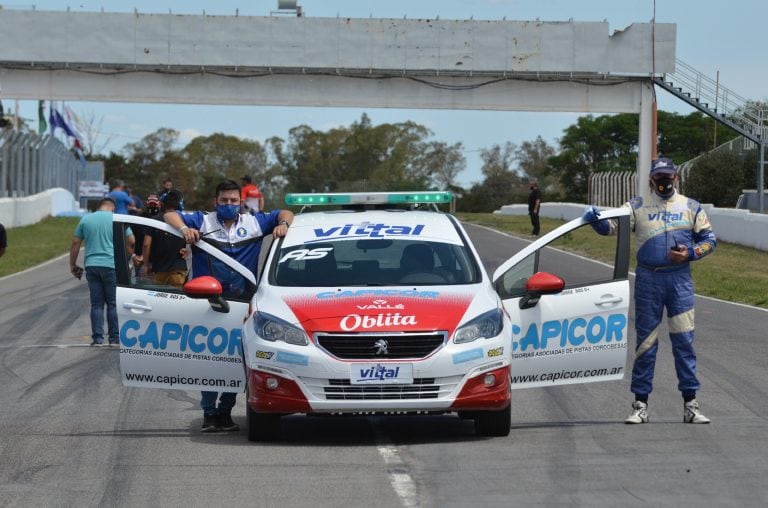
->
[[0, 188, 78, 228]]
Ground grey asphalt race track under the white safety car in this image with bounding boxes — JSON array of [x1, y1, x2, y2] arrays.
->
[[0, 226, 768, 508]]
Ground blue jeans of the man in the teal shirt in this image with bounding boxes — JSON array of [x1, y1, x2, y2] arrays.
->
[[85, 266, 120, 344]]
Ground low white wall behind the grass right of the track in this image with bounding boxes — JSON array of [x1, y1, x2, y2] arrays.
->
[[493, 203, 768, 251]]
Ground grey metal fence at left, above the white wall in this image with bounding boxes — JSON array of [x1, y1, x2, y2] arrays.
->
[[0, 130, 81, 198]]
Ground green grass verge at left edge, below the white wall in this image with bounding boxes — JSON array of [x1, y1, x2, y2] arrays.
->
[[0, 217, 83, 277]]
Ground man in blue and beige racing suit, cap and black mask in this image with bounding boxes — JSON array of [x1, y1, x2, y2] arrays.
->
[[583, 158, 717, 424]]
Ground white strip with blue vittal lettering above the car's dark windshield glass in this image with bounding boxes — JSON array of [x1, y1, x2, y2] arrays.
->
[[283, 209, 464, 247]]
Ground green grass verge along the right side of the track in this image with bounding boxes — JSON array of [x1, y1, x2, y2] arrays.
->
[[456, 213, 768, 308]]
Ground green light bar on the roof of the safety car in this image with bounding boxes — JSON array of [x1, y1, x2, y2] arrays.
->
[[285, 191, 453, 206]]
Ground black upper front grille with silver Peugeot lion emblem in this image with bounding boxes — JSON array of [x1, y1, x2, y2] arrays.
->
[[316, 332, 446, 361]]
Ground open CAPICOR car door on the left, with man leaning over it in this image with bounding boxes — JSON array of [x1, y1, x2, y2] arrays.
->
[[114, 215, 256, 392]]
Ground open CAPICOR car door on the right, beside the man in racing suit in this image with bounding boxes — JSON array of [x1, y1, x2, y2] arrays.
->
[[493, 208, 630, 388]]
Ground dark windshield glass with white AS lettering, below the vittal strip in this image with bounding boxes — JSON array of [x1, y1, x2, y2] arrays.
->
[[269, 239, 480, 287]]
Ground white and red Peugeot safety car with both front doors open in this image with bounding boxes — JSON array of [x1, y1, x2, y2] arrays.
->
[[114, 192, 629, 441]]
